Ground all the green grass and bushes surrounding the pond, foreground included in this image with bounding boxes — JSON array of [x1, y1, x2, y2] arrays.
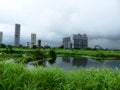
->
[[0, 45, 120, 90]]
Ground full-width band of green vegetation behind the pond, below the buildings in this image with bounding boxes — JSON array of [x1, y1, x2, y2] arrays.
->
[[0, 46, 120, 63]]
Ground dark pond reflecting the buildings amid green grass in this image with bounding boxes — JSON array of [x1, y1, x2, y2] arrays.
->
[[28, 56, 120, 71]]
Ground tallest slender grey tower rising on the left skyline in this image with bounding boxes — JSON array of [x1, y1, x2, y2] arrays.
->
[[14, 24, 20, 47]]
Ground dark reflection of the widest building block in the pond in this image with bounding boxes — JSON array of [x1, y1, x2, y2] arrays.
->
[[72, 57, 88, 67]]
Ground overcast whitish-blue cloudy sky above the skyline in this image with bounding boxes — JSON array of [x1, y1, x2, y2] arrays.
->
[[0, 0, 120, 48]]
